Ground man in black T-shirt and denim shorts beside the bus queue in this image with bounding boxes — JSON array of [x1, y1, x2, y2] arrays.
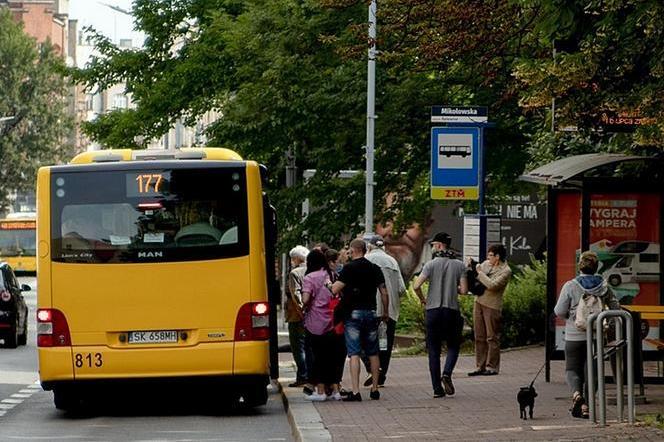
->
[[330, 239, 389, 401]]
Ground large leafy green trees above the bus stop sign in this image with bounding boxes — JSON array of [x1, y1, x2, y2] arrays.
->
[[75, 0, 663, 249]]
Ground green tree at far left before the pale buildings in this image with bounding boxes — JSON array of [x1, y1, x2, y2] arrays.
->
[[0, 8, 72, 209]]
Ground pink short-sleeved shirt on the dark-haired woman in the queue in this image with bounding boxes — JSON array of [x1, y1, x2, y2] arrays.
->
[[302, 270, 333, 335]]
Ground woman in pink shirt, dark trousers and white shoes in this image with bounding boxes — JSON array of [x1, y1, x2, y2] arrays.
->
[[302, 249, 341, 401]]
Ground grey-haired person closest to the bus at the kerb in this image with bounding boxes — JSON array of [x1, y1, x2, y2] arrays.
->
[[286, 245, 309, 387]]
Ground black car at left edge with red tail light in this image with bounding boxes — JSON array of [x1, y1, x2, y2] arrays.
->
[[0, 262, 31, 348]]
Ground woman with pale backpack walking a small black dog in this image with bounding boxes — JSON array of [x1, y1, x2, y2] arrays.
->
[[554, 251, 620, 419]]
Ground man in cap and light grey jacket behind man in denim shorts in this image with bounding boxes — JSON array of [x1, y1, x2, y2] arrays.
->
[[362, 235, 406, 387]]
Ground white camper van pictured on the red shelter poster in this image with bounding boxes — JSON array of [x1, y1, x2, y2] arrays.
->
[[603, 241, 660, 287]]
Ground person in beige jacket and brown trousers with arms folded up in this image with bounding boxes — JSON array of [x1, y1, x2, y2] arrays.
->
[[468, 244, 512, 376]]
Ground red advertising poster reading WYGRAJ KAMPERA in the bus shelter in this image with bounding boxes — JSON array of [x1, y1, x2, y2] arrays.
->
[[556, 193, 661, 351]]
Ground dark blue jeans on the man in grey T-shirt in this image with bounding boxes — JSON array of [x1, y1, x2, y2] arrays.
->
[[426, 307, 463, 390]]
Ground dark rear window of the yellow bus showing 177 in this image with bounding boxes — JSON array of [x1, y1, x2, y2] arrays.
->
[[51, 167, 249, 263]]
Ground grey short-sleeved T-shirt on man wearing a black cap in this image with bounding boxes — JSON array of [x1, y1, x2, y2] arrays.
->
[[422, 258, 466, 310]]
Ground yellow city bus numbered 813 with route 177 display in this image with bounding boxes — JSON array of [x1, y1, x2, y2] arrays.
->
[[37, 148, 276, 410]]
